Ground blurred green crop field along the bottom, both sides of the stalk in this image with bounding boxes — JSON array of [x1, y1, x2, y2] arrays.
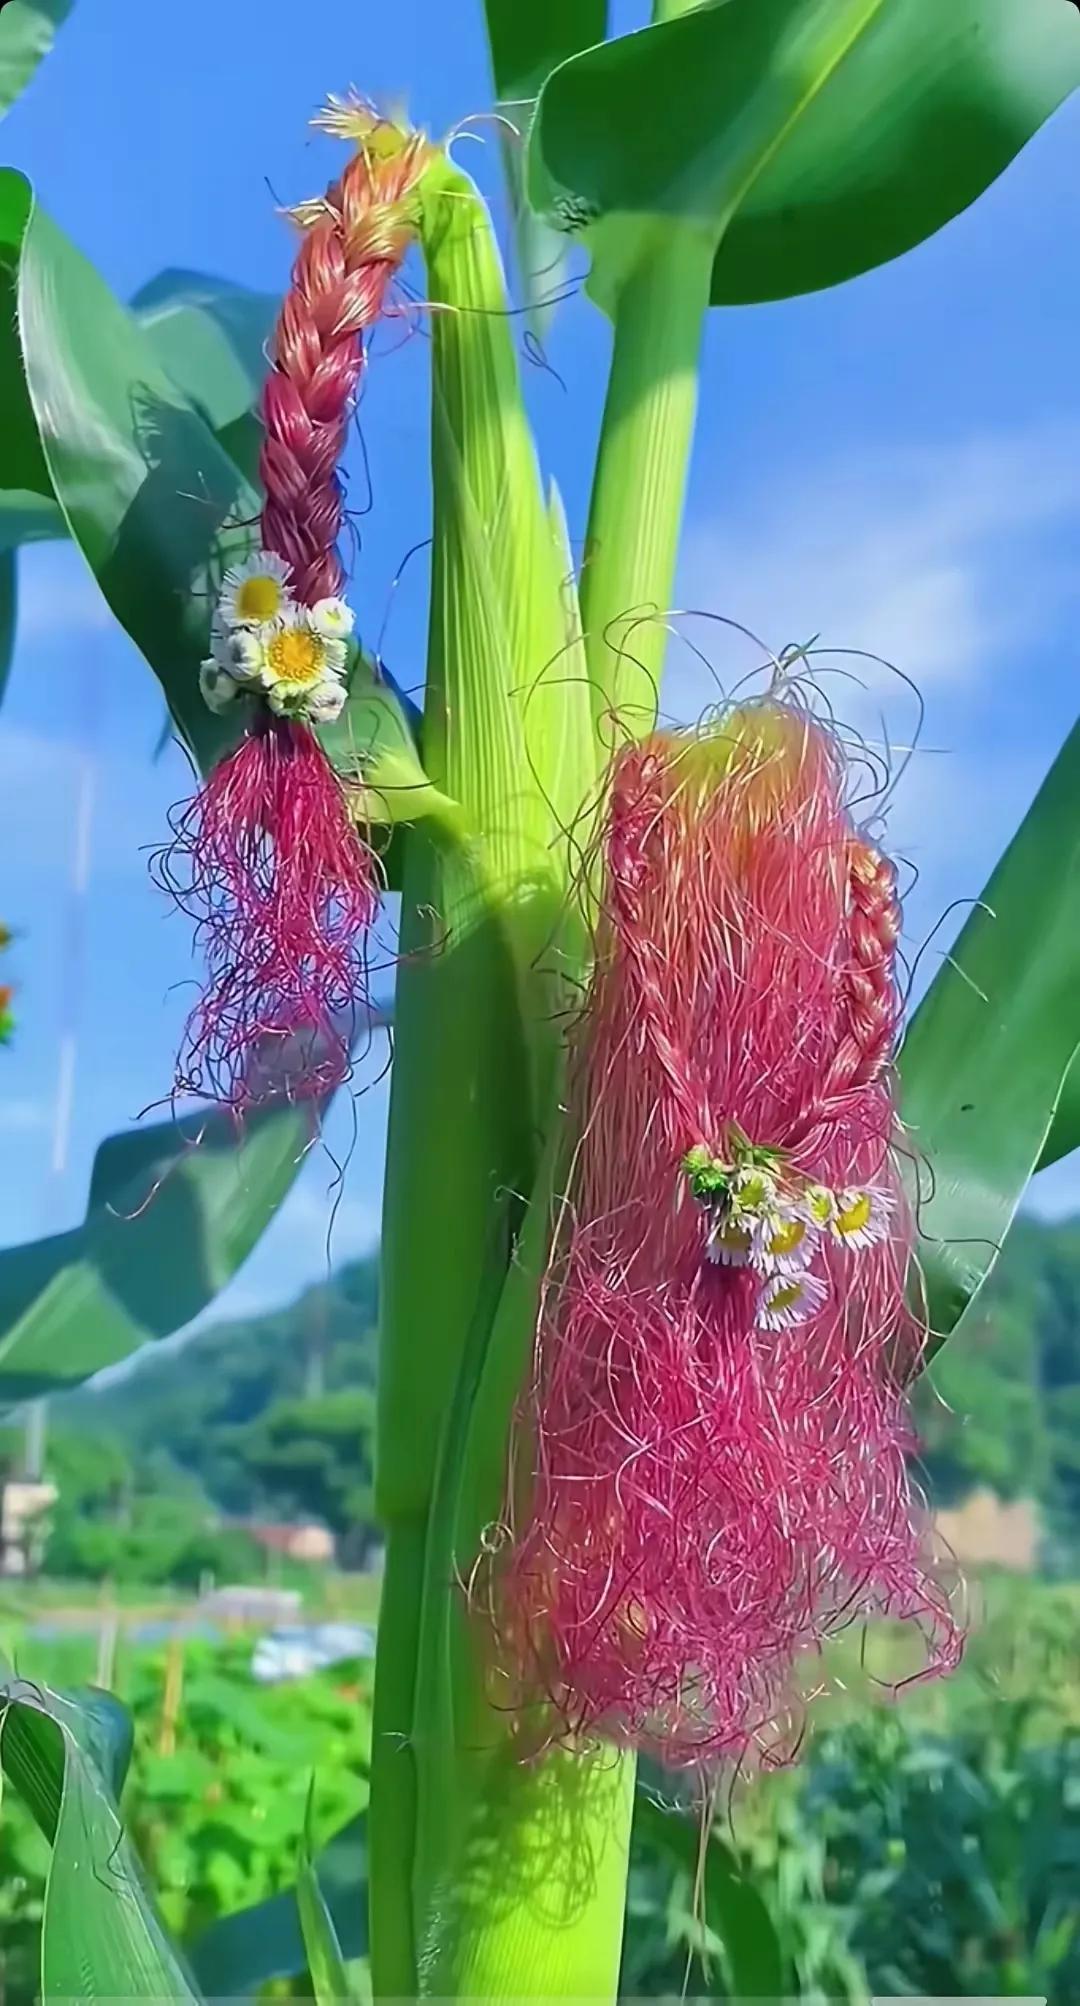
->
[[0, 1577, 1080, 2006]]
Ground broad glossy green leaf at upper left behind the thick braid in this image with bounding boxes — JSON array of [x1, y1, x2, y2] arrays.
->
[[0, 169, 259, 768]]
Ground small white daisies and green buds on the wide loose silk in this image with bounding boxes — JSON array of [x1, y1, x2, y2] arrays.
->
[[683, 1123, 893, 1330]]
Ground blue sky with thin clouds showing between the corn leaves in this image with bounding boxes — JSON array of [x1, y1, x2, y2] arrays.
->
[[0, 0, 1080, 1340]]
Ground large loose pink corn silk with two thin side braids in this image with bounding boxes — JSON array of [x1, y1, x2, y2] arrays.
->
[[494, 702, 962, 1765]]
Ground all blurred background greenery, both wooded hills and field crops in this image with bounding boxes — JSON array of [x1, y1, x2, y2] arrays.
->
[[0, 1220, 1080, 2006]]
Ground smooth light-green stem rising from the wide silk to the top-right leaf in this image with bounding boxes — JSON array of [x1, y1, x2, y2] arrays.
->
[[582, 221, 713, 742]]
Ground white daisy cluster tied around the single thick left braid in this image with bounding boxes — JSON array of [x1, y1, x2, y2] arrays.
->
[[199, 550, 353, 724]]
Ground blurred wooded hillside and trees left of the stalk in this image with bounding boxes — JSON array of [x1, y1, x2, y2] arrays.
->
[[0, 1260, 375, 1589]]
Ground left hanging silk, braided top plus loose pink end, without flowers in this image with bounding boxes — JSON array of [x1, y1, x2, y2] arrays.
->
[[161, 123, 426, 1113]]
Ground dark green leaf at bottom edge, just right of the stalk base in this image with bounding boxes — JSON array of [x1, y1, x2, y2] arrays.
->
[[634, 1789, 782, 2000]]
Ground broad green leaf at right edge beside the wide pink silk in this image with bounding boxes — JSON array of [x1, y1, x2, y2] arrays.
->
[[899, 724, 1080, 1342]]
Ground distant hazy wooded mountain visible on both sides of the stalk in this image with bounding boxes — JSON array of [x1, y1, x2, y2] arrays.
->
[[56, 1218, 1080, 1543]]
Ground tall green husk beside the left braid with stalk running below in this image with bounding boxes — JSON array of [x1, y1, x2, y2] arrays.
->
[[369, 160, 574, 2000]]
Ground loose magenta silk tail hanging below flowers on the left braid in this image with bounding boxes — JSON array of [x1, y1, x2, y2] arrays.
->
[[167, 718, 377, 1113]]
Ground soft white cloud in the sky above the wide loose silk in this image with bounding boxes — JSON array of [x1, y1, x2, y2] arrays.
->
[[664, 419, 1080, 714]]
